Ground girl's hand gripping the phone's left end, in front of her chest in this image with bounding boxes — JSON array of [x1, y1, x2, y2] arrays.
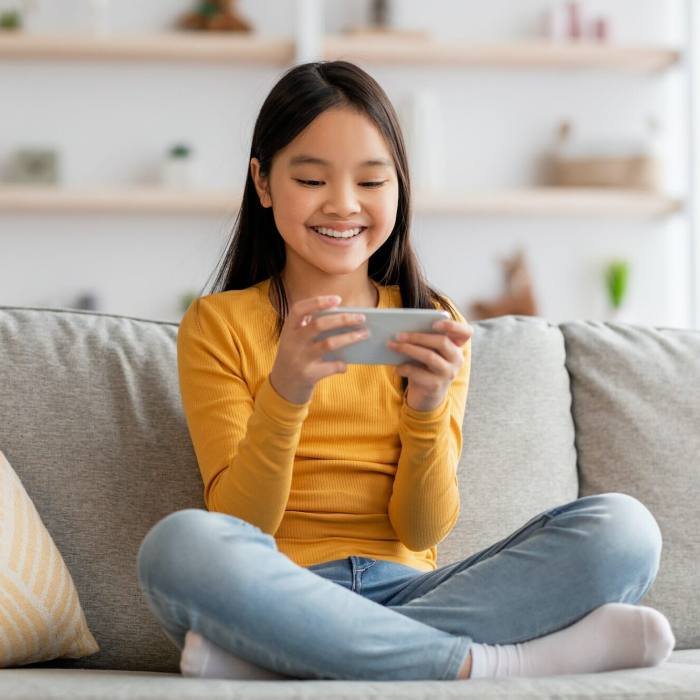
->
[[270, 296, 368, 404]]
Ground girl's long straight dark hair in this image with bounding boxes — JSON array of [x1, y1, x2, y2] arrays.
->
[[205, 61, 457, 340]]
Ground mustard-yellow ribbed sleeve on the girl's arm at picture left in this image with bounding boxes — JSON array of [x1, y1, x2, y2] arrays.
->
[[177, 299, 309, 534]]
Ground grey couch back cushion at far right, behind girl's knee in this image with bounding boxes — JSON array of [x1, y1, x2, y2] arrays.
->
[[562, 321, 700, 649]]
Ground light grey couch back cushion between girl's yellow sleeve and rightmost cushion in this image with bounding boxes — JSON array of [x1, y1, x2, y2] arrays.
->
[[438, 316, 578, 566]]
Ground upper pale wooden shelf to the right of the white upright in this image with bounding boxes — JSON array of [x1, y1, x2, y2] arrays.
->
[[323, 35, 681, 72]]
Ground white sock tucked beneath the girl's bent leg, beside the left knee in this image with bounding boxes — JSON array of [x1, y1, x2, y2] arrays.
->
[[180, 630, 291, 681]]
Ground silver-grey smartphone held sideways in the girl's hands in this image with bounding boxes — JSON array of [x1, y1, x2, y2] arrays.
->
[[313, 306, 452, 365]]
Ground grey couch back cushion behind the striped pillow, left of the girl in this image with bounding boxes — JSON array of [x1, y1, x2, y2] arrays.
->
[[0, 308, 203, 672]]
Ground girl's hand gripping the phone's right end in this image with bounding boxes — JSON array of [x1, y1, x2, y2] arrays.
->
[[387, 320, 474, 411]]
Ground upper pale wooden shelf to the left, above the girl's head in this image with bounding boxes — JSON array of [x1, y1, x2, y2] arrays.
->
[[0, 31, 294, 64]]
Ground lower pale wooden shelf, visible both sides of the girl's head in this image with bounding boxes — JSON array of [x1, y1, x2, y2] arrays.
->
[[0, 185, 682, 217]]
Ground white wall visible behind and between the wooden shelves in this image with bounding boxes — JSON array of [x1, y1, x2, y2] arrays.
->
[[0, 0, 689, 326]]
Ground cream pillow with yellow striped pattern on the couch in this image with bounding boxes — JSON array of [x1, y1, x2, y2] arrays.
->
[[0, 452, 100, 668]]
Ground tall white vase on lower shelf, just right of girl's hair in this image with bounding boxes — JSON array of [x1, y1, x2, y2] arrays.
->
[[398, 90, 445, 192]]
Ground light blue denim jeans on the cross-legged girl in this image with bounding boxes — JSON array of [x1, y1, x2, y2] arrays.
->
[[138, 493, 661, 680]]
